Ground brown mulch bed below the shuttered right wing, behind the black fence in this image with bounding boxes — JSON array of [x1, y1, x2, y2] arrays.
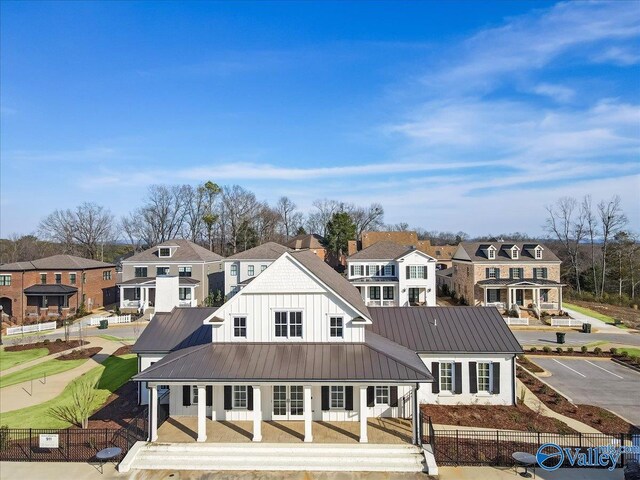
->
[[421, 405, 575, 433]]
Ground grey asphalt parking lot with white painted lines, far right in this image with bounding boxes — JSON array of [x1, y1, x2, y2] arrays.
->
[[531, 356, 640, 426]]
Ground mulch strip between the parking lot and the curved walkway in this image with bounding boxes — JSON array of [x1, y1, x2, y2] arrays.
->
[[516, 368, 640, 433]]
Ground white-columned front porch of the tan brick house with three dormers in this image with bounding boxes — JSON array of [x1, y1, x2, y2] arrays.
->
[[478, 279, 563, 318]]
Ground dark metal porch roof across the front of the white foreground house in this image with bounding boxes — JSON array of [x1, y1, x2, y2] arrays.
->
[[133, 339, 433, 383]]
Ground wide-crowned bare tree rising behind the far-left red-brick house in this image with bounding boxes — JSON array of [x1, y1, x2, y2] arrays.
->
[[39, 202, 114, 258]]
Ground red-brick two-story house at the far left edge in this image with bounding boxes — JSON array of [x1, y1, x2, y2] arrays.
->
[[0, 255, 116, 322]]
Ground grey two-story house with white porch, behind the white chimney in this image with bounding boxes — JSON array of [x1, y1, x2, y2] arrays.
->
[[118, 239, 223, 312]]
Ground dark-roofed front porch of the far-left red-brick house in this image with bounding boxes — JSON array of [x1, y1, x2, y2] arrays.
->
[[24, 284, 78, 319]]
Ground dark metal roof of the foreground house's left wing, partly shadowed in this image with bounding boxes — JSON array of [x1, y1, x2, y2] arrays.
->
[[133, 307, 217, 353]]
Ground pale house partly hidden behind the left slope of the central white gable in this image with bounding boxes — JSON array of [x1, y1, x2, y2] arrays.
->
[[224, 242, 291, 297]]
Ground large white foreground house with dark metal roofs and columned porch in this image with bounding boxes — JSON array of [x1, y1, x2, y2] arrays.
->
[[133, 251, 522, 443]]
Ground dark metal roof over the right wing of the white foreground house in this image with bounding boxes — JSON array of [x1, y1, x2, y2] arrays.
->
[[367, 307, 522, 353]]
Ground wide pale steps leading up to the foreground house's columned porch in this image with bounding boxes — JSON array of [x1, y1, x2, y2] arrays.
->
[[119, 443, 424, 472]]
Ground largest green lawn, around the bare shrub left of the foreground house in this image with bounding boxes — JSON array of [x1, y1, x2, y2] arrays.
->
[[1, 354, 138, 428]]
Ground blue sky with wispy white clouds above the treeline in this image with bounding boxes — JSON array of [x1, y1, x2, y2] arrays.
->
[[0, 1, 640, 237]]
